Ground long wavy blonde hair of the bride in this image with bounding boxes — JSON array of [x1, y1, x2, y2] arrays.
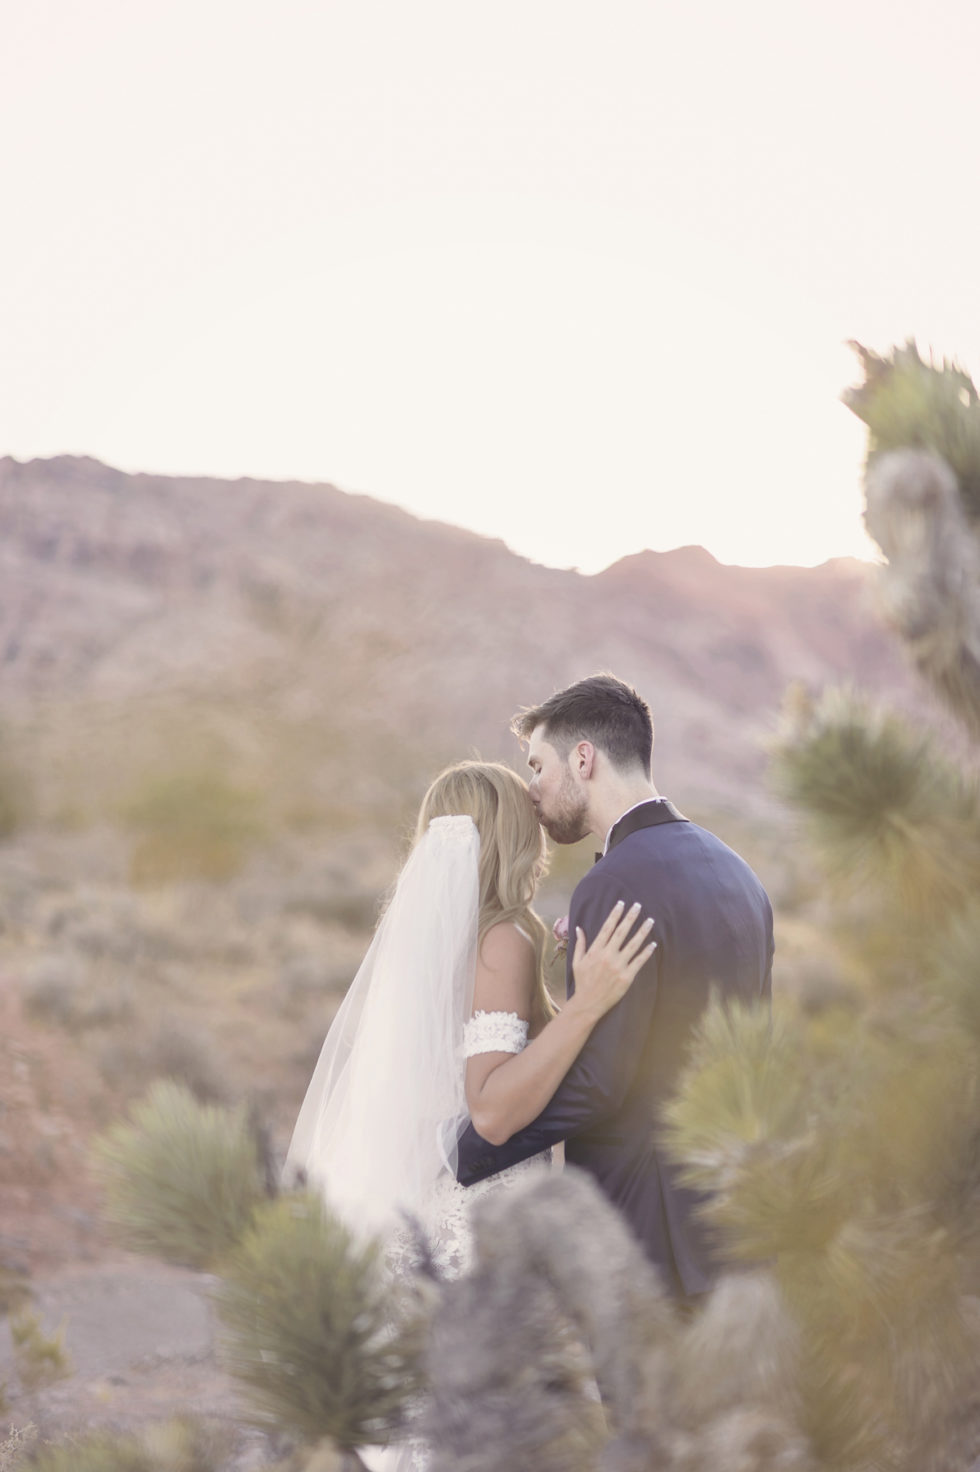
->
[[415, 761, 555, 1020]]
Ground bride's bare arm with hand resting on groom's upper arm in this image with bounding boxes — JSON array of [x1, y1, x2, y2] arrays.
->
[[466, 904, 656, 1145]]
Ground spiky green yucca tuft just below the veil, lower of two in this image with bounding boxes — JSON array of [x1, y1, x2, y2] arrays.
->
[[215, 1195, 419, 1447]]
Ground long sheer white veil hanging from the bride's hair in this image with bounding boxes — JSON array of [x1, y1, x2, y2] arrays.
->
[[285, 817, 480, 1234]]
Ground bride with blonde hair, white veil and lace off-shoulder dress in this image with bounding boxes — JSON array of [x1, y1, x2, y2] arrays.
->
[[285, 761, 655, 1465]]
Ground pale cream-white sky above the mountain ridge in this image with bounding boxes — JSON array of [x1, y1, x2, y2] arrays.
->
[[0, 0, 980, 571]]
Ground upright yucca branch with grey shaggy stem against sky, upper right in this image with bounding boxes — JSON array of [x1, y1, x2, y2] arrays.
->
[[843, 343, 980, 733]]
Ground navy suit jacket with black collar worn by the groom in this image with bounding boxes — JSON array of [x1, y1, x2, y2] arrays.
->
[[456, 798, 773, 1294]]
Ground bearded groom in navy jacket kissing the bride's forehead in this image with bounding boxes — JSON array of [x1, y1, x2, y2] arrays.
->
[[456, 674, 773, 1298]]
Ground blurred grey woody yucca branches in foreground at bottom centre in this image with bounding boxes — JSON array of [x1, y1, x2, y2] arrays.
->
[[424, 1169, 817, 1472]]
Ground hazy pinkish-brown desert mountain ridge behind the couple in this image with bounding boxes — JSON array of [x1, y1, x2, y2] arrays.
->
[[0, 456, 917, 808]]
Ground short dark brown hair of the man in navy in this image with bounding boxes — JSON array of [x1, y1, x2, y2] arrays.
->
[[511, 674, 653, 774]]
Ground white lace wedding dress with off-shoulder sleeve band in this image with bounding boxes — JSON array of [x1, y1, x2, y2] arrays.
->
[[367, 1011, 552, 1472]]
